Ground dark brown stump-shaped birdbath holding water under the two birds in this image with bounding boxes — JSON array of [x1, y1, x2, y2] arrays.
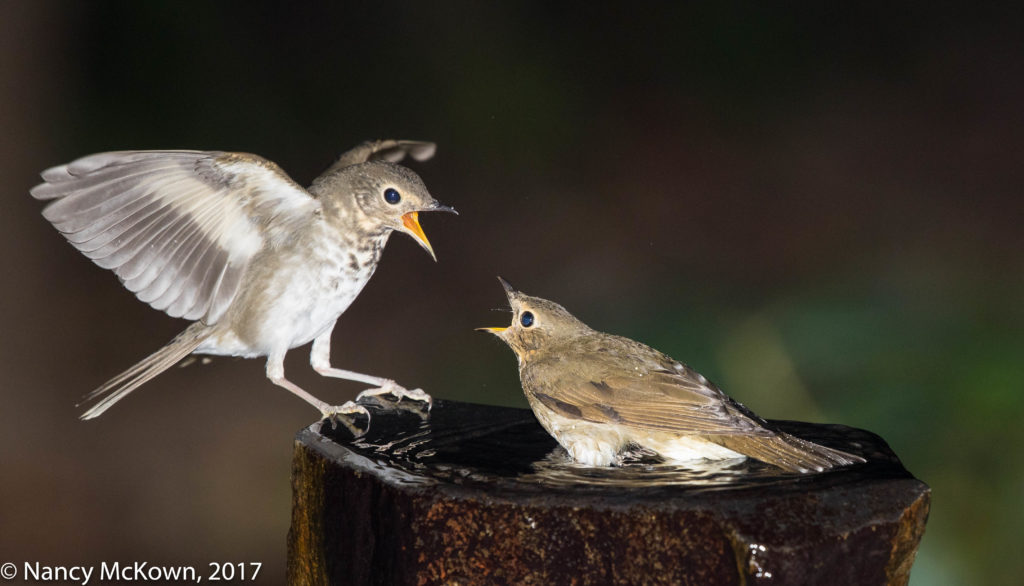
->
[[288, 401, 931, 586]]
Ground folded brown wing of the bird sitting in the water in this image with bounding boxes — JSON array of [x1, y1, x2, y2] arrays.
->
[[521, 340, 772, 435]]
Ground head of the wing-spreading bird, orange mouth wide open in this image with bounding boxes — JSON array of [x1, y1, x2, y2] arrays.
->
[[310, 160, 458, 260]]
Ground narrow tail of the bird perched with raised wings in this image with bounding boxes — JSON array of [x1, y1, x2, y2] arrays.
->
[[75, 322, 210, 420]]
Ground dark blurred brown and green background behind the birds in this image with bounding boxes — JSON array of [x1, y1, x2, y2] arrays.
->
[[0, 1, 1024, 585]]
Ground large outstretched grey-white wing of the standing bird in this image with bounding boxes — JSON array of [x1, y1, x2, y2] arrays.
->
[[32, 151, 319, 324]]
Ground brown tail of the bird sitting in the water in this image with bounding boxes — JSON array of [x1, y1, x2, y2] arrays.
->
[[708, 432, 865, 472]]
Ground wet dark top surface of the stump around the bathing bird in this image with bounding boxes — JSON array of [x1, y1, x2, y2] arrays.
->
[[297, 401, 928, 507]]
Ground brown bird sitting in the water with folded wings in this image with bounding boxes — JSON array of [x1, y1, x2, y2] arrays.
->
[[477, 277, 864, 473]]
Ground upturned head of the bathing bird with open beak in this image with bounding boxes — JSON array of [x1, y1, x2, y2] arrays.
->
[[477, 277, 591, 362]]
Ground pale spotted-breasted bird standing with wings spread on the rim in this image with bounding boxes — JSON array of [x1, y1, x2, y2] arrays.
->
[[30, 140, 457, 424]]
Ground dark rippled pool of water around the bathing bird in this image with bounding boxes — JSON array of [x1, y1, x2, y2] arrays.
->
[[322, 401, 906, 497]]
